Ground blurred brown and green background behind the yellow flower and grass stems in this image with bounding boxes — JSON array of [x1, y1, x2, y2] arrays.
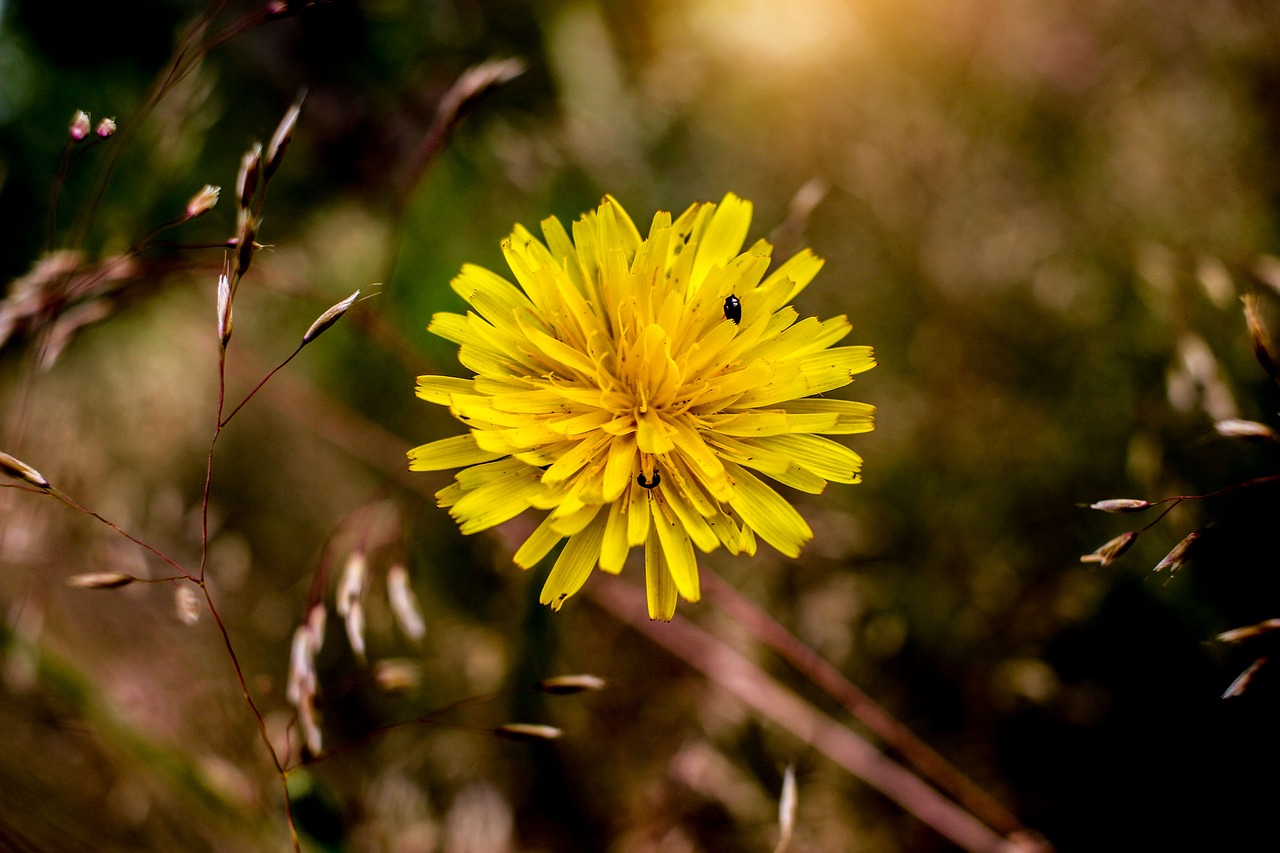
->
[[0, 0, 1280, 852]]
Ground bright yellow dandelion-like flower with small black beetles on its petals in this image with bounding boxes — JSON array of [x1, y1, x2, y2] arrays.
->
[[408, 195, 876, 620]]
